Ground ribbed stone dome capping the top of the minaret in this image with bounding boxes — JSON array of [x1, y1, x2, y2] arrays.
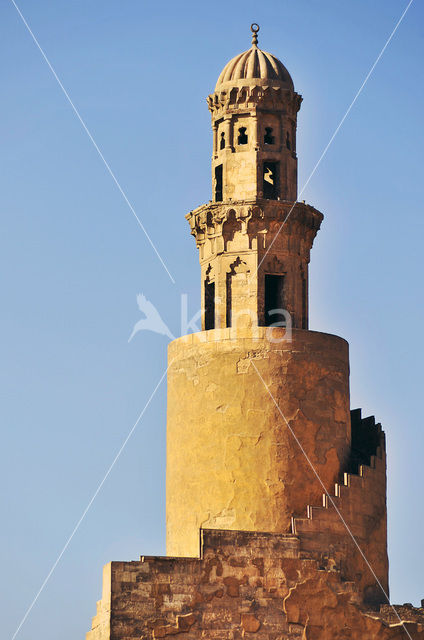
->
[[215, 44, 294, 91]]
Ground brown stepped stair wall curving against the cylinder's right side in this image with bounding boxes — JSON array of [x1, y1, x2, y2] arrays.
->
[[291, 416, 389, 603]]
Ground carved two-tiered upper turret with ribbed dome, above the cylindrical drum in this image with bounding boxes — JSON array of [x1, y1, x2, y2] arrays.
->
[[187, 25, 322, 330]]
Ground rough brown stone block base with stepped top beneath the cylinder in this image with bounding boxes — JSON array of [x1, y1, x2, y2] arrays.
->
[[87, 531, 424, 640]]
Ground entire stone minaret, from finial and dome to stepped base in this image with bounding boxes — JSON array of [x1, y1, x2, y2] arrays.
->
[[87, 25, 424, 640]]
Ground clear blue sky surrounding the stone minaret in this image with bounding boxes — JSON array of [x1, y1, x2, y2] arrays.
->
[[0, 0, 424, 640]]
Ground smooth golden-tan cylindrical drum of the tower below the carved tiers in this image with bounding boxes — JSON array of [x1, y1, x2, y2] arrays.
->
[[166, 327, 350, 556]]
